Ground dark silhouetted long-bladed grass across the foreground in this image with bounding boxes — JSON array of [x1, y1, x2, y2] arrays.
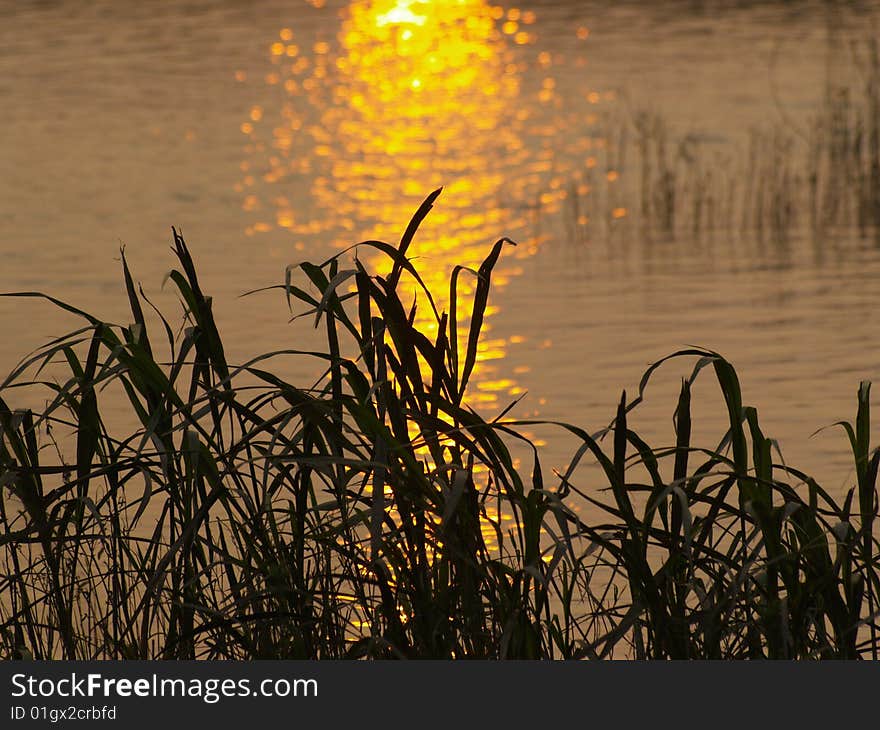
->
[[0, 191, 880, 659]]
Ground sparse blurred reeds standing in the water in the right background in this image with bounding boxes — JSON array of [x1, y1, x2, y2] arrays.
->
[[566, 38, 880, 244]]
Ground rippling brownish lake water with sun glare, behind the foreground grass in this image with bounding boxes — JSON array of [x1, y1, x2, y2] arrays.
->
[[0, 0, 880, 490]]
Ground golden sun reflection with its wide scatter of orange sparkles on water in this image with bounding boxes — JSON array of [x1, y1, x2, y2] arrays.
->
[[238, 0, 604, 407]]
